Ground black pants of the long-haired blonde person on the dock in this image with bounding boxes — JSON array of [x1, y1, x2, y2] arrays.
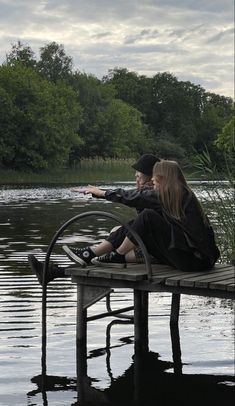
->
[[126, 209, 211, 272]]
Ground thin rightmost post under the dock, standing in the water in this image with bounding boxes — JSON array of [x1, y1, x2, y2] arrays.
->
[[170, 293, 182, 374]]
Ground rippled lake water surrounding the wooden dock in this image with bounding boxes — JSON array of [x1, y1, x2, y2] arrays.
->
[[0, 185, 234, 406]]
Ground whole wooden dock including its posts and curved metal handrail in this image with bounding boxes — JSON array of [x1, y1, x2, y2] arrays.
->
[[39, 211, 235, 405]]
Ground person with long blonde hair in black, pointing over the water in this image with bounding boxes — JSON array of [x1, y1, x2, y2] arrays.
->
[[85, 160, 220, 271]]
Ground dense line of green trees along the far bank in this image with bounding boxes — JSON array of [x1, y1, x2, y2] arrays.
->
[[0, 42, 234, 171]]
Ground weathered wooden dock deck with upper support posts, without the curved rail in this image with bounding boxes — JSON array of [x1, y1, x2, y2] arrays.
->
[[67, 264, 235, 351]]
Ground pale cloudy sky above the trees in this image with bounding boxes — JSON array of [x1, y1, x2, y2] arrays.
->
[[0, 0, 234, 97]]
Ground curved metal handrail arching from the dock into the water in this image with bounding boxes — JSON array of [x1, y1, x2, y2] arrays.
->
[[42, 211, 152, 376]]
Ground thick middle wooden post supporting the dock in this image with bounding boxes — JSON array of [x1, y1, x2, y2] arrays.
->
[[134, 289, 148, 353]]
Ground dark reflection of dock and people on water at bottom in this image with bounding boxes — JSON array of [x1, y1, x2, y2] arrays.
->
[[27, 320, 234, 406]]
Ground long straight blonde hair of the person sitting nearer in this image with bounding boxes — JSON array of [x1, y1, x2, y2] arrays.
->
[[153, 159, 192, 220]]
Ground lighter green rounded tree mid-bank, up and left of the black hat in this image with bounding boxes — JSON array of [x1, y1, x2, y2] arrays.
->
[[70, 72, 147, 161]]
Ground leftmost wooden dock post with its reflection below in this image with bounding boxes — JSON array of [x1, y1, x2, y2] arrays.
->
[[76, 285, 87, 404]]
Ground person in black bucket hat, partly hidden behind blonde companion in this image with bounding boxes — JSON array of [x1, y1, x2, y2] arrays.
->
[[28, 154, 159, 283]]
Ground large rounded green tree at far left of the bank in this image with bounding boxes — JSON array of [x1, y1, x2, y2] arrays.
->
[[0, 63, 81, 170]]
